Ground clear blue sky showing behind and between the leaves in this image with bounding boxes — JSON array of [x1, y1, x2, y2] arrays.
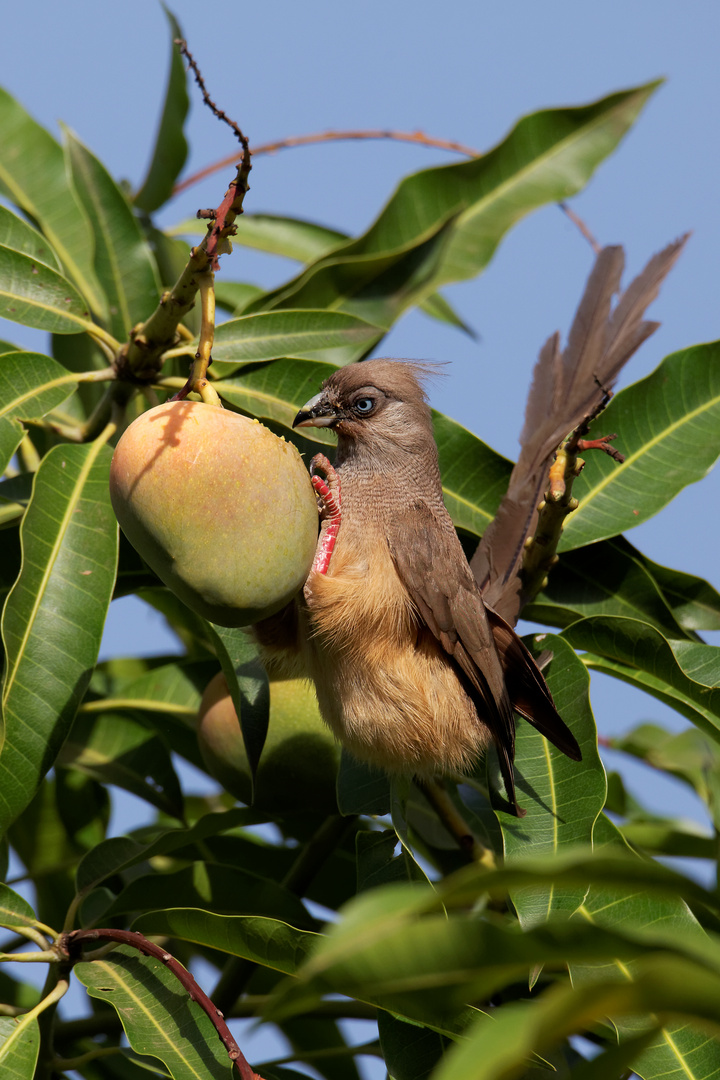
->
[[0, 0, 720, 825]]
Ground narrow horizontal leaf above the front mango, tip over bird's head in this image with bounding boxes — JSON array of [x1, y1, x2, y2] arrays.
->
[[213, 310, 384, 373]]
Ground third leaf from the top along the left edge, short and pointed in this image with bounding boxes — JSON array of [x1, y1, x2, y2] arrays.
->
[[0, 247, 94, 334]]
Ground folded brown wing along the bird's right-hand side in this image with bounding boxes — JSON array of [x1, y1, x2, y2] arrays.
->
[[388, 501, 519, 812]]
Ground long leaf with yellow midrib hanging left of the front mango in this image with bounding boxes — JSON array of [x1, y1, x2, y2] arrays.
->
[[0, 441, 118, 831]]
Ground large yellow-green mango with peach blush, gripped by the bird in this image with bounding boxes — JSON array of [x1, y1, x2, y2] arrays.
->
[[110, 401, 317, 626]]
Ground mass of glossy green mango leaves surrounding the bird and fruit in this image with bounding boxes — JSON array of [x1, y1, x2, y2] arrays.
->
[[0, 10, 720, 1080]]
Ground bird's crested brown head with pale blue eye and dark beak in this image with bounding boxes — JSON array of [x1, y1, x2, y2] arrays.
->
[[293, 360, 434, 457]]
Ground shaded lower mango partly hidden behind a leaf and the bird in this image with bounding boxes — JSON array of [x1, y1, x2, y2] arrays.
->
[[198, 672, 340, 813]]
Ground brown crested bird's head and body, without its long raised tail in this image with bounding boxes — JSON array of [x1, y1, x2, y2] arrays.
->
[[255, 359, 581, 816]]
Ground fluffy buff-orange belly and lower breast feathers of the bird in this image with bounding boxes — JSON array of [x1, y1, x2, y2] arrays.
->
[[305, 517, 488, 775]]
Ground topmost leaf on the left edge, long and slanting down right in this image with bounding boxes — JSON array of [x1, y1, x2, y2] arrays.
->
[[0, 90, 105, 315]]
